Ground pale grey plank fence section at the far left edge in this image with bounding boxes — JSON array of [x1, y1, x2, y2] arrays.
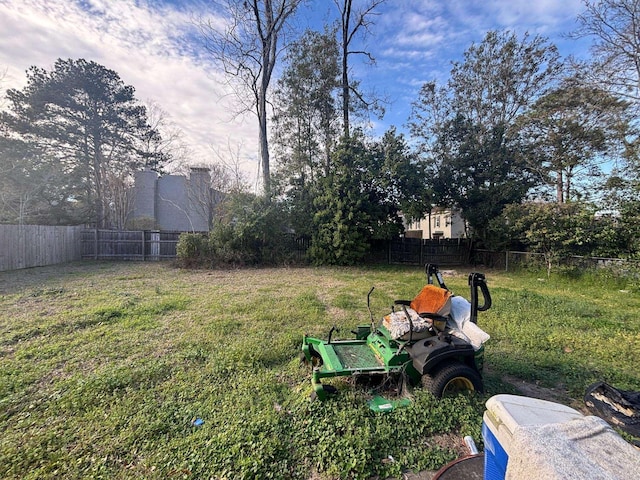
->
[[0, 224, 83, 271]]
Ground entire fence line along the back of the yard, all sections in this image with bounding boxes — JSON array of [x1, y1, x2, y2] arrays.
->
[[0, 224, 640, 271]]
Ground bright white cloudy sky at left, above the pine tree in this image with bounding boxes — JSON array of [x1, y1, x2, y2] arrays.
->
[[0, 0, 257, 174]]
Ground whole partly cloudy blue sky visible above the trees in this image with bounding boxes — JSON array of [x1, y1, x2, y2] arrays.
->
[[0, 0, 588, 179]]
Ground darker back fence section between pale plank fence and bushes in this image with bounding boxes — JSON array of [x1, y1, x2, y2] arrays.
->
[[82, 229, 181, 260]]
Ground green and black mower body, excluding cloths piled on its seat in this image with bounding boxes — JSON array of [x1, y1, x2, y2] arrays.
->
[[302, 264, 491, 400]]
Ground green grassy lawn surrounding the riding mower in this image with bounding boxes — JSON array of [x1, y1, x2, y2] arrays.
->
[[0, 263, 640, 479]]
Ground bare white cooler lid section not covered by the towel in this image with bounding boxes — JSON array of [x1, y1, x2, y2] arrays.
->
[[486, 394, 583, 434]]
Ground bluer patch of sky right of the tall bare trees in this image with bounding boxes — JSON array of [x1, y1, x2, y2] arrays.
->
[[366, 0, 588, 130]]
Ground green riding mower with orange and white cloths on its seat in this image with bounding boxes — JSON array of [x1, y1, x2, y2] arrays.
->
[[302, 264, 491, 410]]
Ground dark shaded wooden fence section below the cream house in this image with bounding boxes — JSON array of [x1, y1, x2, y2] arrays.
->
[[389, 238, 471, 265]]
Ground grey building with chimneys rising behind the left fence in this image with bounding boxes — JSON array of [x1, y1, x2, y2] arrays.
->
[[129, 168, 216, 232]]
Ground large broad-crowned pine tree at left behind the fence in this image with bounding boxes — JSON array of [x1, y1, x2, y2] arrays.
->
[[0, 59, 165, 227]]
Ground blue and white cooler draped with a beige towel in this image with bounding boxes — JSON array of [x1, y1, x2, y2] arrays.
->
[[482, 395, 640, 480]]
